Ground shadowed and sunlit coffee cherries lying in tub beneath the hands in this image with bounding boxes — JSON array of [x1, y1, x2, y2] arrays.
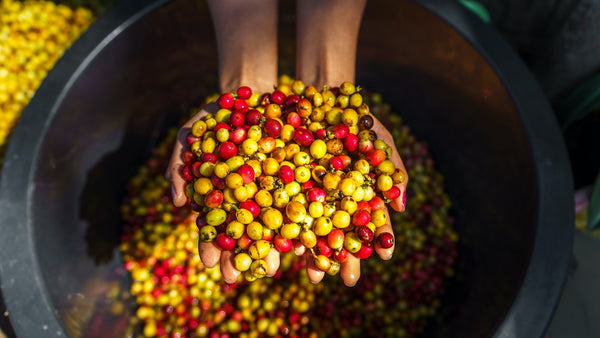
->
[[99, 82, 457, 337]]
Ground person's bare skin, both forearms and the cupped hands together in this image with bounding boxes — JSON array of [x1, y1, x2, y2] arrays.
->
[[166, 0, 408, 286]]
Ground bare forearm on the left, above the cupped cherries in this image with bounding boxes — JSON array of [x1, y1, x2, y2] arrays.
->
[[208, 0, 277, 93]]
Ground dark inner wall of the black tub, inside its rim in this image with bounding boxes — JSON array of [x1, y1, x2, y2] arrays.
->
[[31, 1, 537, 337]]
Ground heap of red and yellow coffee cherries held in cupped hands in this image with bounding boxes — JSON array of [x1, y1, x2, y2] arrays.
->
[[182, 81, 406, 280]]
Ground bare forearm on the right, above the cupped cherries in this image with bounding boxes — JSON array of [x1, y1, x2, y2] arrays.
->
[[296, 0, 366, 88]]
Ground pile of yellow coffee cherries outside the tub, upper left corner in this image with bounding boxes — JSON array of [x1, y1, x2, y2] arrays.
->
[[0, 0, 94, 167]]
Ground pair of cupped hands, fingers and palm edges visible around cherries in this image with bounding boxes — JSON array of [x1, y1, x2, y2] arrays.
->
[[166, 93, 408, 286]]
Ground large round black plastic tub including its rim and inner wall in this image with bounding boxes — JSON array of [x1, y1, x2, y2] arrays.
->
[[0, 0, 574, 337]]
